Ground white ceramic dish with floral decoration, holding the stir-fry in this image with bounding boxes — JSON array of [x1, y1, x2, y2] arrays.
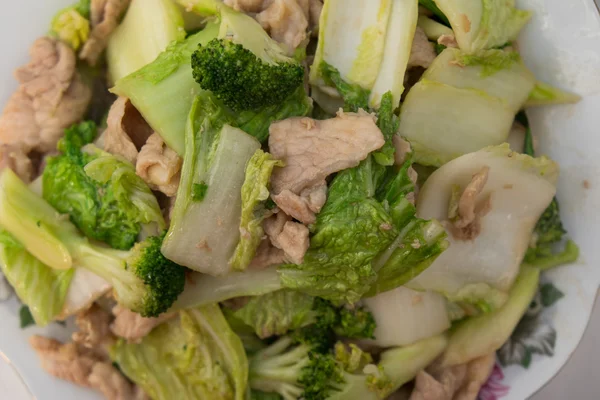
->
[[0, 0, 600, 400]]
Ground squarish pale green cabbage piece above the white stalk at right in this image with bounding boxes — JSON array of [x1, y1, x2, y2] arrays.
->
[[399, 49, 535, 167]]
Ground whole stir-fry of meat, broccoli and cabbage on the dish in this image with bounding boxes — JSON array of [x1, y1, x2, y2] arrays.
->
[[0, 0, 579, 400]]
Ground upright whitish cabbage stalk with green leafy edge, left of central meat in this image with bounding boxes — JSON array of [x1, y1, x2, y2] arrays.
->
[[162, 93, 260, 275]]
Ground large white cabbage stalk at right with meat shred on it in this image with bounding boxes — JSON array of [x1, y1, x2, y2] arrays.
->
[[407, 144, 558, 311]]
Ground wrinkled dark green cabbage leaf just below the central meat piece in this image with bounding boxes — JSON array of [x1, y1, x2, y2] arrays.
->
[[280, 153, 447, 303]]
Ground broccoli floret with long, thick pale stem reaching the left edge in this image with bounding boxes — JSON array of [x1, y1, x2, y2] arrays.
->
[[0, 169, 185, 317]]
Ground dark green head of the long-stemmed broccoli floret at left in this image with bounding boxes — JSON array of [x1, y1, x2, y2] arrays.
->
[[126, 236, 190, 317]]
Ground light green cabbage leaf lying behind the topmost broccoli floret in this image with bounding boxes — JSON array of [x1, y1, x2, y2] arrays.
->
[[112, 15, 312, 155]]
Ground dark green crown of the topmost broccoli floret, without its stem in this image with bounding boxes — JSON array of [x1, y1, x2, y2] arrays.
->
[[192, 39, 304, 111]]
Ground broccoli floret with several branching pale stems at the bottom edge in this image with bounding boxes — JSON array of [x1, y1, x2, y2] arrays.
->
[[250, 298, 375, 400]]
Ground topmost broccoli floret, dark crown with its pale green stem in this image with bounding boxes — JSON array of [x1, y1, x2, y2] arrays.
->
[[192, 7, 304, 111]]
